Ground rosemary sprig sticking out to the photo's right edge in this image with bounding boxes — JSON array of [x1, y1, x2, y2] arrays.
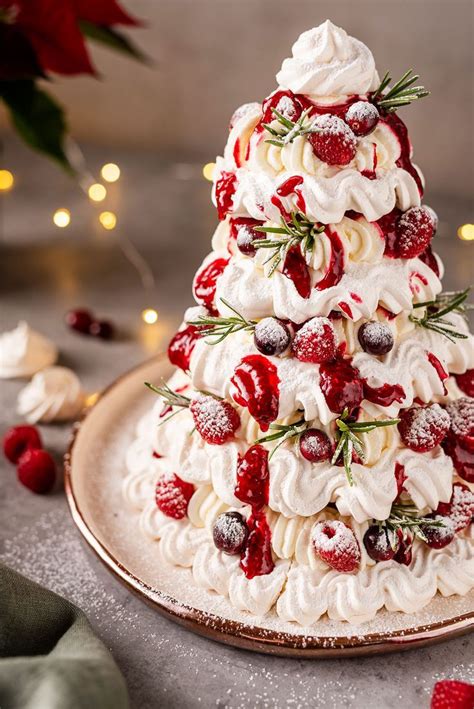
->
[[409, 287, 472, 342]]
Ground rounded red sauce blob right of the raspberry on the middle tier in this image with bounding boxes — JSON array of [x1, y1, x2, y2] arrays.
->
[[231, 355, 280, 431]]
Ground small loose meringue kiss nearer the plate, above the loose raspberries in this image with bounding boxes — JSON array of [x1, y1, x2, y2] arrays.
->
[[17, 367, 85, 423]]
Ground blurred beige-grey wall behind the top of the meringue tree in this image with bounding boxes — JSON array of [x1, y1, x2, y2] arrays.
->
[[0, 0, 474, 197]]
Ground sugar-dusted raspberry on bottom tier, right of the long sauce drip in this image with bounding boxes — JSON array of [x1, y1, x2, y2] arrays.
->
[[311, 520, 360, 572]]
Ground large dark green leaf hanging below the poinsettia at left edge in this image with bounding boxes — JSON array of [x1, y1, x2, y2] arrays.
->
[[0, 80, 75, 174]]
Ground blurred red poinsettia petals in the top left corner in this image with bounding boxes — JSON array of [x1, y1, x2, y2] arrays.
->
[[0, 0, 138, 74]]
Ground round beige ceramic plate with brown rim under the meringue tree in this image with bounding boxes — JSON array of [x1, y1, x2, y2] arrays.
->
[[65, 355, 474, 658]]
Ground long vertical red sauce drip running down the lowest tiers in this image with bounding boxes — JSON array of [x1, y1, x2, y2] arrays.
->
[[235, 444, 275, 579]]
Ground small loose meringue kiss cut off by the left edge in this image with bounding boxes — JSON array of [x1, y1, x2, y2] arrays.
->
[[0, 321, 58, 379]]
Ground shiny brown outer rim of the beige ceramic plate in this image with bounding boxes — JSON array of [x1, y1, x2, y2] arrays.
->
[[64, 352, 474, 659]]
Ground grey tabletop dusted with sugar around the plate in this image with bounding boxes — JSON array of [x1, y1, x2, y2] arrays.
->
[[0, 145, 474, 708]]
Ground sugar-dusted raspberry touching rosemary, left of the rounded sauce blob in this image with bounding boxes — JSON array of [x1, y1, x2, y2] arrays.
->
[[189, 394, 240, 446]]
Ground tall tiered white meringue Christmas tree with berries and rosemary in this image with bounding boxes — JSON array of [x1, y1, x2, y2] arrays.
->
[[124, 21, 474, 625]]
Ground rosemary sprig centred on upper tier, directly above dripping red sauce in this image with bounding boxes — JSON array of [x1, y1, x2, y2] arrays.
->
[[252, 212, 326, 277]]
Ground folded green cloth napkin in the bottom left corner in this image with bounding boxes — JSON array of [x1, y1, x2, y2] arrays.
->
[[0, 564, 129, 709]]
